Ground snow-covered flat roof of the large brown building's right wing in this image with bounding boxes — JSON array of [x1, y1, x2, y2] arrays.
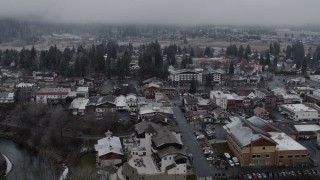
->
[[269, 132, 307, 151]]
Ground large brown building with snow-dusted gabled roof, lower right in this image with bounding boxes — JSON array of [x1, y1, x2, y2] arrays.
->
[[224, 116, 309, 166]]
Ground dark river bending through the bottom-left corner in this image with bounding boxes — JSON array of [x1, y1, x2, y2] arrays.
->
[[0, 139, 43, 180]]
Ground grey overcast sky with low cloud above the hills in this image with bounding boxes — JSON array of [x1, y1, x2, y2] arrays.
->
[[0, 0, 320, 25]]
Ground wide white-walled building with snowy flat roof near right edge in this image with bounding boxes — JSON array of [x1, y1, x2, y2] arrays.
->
[[279, 103, 320, 121]]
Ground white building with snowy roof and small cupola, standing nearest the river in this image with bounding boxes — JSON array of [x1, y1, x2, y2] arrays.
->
[[94, 131, 124, 167]]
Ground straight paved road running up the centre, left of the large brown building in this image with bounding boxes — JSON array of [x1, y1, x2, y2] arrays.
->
[[173, 100, 220, 176]]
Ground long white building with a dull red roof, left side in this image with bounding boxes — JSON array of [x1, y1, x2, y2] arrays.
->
[[36, 88, 71, 104]]
